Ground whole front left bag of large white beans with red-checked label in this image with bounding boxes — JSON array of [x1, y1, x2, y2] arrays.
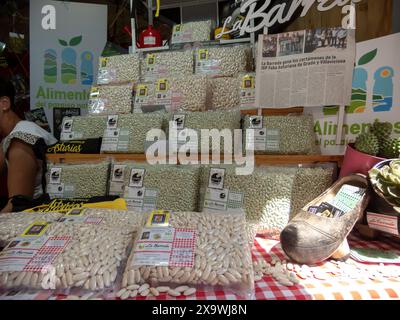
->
[[0, 211, 141, 292]]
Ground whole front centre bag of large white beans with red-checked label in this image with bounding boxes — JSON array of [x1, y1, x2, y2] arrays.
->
[[121, 211, 254, 299]]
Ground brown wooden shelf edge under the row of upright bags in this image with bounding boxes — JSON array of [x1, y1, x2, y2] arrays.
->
[[47, 153, 343, 167]]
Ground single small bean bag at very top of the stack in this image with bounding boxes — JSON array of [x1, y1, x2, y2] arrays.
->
[[171, 20, 212, 44]]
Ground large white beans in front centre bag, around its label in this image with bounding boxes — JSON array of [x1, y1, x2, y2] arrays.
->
[[120, 212, 254, 298]]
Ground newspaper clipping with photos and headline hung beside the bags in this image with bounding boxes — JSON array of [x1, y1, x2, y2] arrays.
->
[[256, 28, 355, 108]]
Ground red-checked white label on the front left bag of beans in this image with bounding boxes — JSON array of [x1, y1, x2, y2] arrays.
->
[[0, 235, 72, 272]]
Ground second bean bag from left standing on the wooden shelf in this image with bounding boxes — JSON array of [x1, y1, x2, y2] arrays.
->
[[101, 113, 164, 153]]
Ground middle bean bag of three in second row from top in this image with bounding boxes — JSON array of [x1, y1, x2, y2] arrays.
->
[[140, 50, 194, 81]]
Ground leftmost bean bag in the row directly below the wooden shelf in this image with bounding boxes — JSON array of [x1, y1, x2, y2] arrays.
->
[[46, 161, 110, 199]]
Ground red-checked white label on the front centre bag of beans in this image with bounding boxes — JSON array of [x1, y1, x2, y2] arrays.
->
[[133, 227, 196, 267]]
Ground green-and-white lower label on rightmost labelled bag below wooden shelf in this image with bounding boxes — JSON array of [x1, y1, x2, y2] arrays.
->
[[203, 188, 243, 212]]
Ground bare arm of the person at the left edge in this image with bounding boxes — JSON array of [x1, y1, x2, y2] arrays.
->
[[1, 139, 39, 213]]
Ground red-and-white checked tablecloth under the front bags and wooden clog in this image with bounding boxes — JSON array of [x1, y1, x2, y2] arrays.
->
[[0, 235, 400, 300]]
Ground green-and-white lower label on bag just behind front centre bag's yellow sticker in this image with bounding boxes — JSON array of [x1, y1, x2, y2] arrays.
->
[[124, 186, 158, 211]]
